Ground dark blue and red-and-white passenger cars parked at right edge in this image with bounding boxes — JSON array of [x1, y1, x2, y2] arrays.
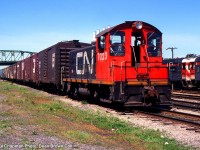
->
[[163, 54, 200, 89]]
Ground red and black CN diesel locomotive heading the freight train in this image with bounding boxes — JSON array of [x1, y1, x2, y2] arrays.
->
[[64, 21, 170, 106]]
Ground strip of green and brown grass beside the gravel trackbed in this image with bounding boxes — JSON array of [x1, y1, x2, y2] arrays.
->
[[0, 82, 193, 150]]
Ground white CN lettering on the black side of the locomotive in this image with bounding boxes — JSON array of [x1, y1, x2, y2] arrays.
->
[[76, 50, 94, 75]]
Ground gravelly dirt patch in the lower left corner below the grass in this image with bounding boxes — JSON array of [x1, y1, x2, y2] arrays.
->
[[0, 82, 123, 150]]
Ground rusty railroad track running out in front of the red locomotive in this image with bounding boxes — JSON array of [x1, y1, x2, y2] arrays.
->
[[138, 108, 200, 132]]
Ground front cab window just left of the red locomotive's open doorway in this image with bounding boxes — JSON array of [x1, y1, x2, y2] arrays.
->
[[110, 31, 125, 56]]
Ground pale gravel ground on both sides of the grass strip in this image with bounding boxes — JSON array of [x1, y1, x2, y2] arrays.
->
[[0, 81, 200, 150]]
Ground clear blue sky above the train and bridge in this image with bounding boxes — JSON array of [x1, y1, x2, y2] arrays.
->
[[0, 0, 200, 63]]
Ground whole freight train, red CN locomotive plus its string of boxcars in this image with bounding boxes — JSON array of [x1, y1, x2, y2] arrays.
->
[[1, 21, 171, 106]]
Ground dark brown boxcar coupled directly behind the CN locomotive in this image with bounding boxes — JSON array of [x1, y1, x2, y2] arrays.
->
[[38, 40, 91, 89]]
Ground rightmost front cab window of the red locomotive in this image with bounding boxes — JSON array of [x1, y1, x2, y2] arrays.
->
[[147, 32, 161, 57]]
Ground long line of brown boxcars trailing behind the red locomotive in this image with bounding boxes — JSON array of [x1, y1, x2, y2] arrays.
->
[[3, 40, 91, 90]]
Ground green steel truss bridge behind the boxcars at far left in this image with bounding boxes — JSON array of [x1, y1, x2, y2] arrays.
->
[[0, 50, 34, 66]]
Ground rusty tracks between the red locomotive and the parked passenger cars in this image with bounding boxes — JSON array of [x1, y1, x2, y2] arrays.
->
[[171, 91, 200, 110]]
